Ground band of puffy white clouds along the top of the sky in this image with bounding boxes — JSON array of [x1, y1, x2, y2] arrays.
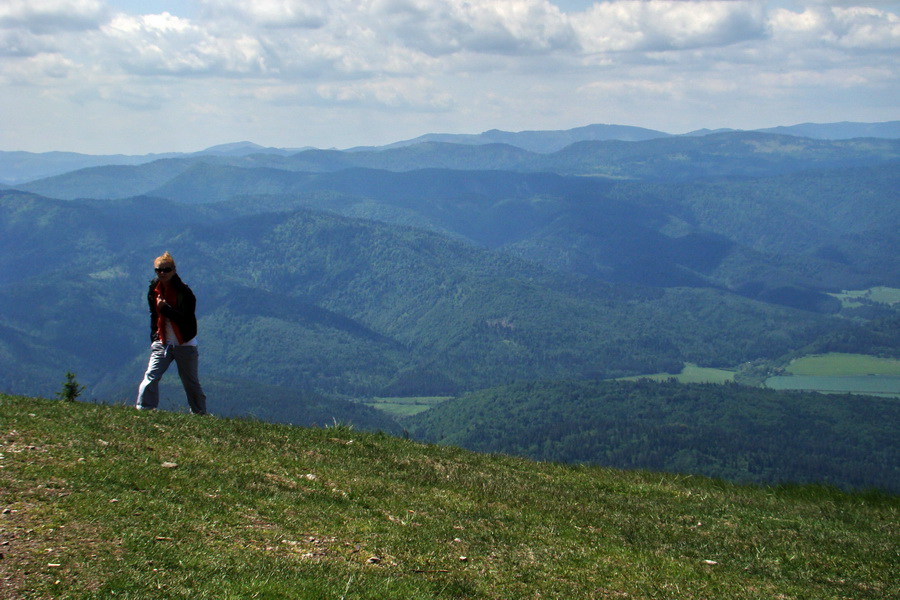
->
[[0, 0, 900, 81]]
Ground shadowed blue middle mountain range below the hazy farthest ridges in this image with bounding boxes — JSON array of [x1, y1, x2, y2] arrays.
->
[[10, 155, 900, 311]]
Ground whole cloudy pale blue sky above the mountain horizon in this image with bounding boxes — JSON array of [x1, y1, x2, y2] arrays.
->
[[0, 0, 900, 154]]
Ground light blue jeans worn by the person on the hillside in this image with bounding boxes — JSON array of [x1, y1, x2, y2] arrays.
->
[[137, 342, 206, 415]]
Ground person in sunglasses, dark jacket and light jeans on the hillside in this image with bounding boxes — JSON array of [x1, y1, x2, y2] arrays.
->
[[137, 252, 206, 415]]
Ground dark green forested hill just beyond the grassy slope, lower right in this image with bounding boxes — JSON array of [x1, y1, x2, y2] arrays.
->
[[406, 380, 900, 493]]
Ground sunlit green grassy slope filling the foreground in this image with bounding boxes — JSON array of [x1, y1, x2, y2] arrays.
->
[[0, 396, 900, 600]]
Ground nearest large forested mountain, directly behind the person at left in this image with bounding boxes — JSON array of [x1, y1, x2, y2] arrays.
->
[[0, 192, 829, 404]]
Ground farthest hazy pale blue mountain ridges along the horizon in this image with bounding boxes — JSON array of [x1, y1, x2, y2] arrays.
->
[[16, 132, 900, 199]]
